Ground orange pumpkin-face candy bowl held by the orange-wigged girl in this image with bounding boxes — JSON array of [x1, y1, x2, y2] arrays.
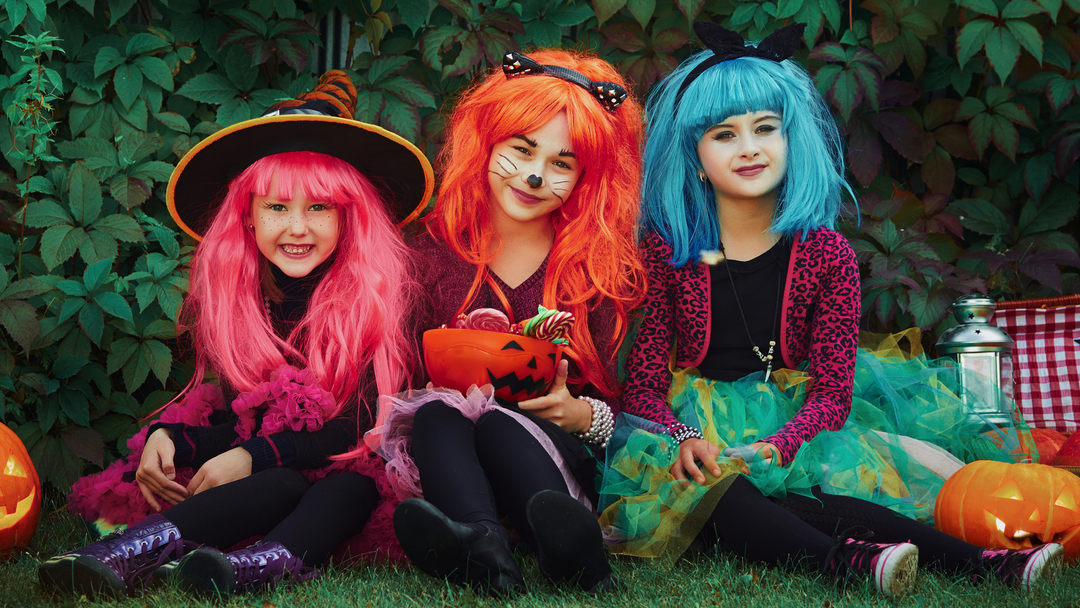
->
[[423, 329, 563, 402]]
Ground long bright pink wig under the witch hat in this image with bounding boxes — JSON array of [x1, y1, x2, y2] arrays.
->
[[181, 151, 417, 416]]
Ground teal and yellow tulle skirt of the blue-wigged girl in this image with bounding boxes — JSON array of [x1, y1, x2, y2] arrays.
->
[[600, 333, 1034, 559]]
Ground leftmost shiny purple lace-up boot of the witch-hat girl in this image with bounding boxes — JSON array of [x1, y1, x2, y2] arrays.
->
[[38, 515, 193, 598]]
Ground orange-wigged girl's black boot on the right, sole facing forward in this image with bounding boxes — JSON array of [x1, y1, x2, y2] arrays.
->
[[525, 490, 617, 593]]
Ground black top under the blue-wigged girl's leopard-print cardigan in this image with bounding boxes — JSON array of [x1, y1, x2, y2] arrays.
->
[[698, 238, 792, 382]]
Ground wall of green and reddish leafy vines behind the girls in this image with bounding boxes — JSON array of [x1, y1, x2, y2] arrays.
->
[[0, 0, 1080, 489]]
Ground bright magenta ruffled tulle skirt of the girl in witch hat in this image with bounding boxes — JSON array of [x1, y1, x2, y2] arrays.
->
[[68, 367, 407, 564]]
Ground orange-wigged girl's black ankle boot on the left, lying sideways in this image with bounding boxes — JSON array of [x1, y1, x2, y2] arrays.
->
[[394, 498, 525, 595]]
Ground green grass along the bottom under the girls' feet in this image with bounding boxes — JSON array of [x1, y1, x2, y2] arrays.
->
[[0, 498, 1080, 608]]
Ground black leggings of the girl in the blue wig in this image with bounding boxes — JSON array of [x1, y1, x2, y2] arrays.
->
[[701, 475, 983, 572]]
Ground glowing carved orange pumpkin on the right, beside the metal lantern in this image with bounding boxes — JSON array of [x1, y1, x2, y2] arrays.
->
[[934, 460, 1080, 560]]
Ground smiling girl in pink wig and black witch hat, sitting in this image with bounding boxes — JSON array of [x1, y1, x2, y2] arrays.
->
[[39, 72, 433, 595]]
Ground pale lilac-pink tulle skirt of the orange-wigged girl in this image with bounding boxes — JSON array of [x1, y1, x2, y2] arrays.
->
[[366, 384, 594, 509]]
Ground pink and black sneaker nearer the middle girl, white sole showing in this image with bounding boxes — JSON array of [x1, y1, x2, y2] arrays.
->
[[825, 538, 919, 595]]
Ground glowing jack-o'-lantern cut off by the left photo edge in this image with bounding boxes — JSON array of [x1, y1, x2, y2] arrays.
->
[[0, 424, 41, 553]]
